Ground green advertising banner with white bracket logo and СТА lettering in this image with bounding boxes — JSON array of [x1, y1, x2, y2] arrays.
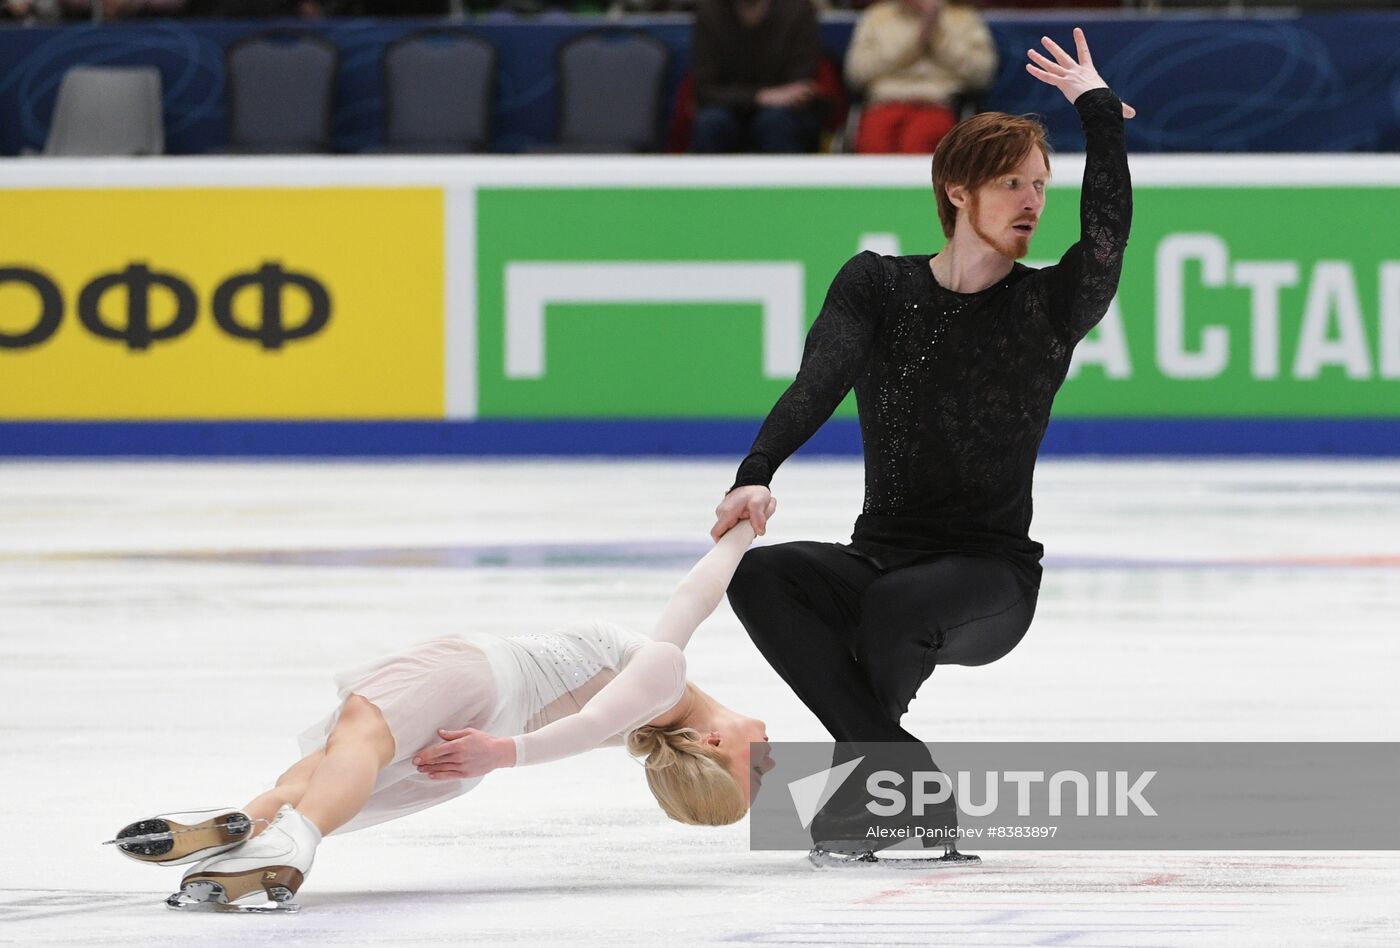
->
[[476, 185, 1400, 419]]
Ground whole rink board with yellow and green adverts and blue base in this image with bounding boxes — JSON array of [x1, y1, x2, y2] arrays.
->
[[0, 155, 1400, 455]]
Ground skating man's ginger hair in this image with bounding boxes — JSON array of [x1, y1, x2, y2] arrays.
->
[[934, 112, 1050, 237]]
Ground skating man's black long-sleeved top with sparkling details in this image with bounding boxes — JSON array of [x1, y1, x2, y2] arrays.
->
[[735, 90, 1133, 585]]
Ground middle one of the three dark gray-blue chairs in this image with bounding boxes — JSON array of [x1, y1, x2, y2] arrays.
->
[[384, 29, 496, 153]]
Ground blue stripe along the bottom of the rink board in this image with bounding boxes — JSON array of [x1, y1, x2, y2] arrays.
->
[[0, 419, 1400, 462]]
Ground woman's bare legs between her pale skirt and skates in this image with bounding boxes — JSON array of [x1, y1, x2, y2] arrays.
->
[[244, 695, 393, 835]]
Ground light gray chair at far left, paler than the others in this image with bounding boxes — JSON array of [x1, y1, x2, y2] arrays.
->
[[43, 66, 165, 155]]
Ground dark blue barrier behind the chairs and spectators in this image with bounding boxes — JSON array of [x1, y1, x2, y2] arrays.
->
[[0, 10, 1400, 155]]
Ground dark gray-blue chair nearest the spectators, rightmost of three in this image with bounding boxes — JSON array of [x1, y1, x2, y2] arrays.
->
[[542, 32, 671, 153]]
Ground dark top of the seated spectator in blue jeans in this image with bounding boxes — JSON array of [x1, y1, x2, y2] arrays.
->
[[690, 0, 822, 109]]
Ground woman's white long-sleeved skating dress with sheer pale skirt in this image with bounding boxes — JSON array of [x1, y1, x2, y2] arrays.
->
[[300, 522, 753, 833]]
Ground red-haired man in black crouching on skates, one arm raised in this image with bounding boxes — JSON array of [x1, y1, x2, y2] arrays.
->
[[713, 28, 1134, 864]]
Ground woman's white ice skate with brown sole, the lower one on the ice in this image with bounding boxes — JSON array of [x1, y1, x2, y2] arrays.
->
[[165, 805, 321, 912]]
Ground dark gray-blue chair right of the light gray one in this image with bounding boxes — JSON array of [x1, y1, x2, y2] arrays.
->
[[227, 34, 339, 154]]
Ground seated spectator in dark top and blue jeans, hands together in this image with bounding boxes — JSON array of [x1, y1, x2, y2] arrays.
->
[[690, 0, 822, 153]]
